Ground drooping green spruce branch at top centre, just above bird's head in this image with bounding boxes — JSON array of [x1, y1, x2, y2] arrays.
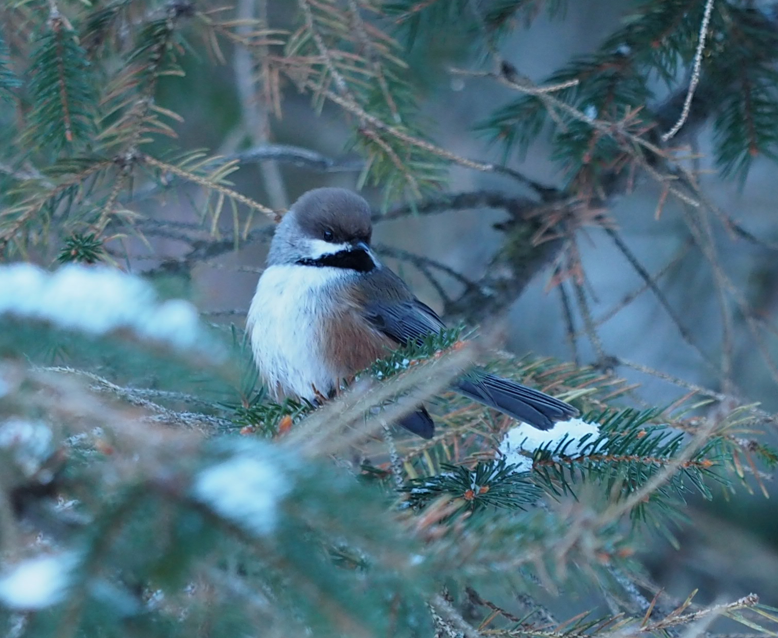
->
[[282, 0, 442, 201]]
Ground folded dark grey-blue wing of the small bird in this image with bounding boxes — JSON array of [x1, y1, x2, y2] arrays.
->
[[362, 268, 445, 345]]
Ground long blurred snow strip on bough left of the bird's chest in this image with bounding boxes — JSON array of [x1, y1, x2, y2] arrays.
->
[[0, 263, 215, 356]]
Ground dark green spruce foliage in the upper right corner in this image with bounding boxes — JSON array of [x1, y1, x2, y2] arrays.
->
[[470, 0, 777, 184]]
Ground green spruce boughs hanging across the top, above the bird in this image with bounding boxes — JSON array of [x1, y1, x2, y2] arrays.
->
[[0, 0, 778, 254]]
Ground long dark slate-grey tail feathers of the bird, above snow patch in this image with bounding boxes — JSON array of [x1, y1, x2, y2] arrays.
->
[[456, 372, 578, 430]]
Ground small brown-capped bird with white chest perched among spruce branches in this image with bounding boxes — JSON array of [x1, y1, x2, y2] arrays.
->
[[247, 188, 578, 439]]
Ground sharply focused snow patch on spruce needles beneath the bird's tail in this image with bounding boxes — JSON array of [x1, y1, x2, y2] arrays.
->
[[500, 419, 600, 472]]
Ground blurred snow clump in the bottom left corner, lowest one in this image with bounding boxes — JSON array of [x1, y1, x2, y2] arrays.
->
[[0, 554, 78, 610]]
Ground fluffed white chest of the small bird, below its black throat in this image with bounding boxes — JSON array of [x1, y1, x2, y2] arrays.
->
[[246, 264, 343, 400]]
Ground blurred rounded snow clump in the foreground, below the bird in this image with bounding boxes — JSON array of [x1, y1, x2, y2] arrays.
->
[[193, 454, 291, 536]]
